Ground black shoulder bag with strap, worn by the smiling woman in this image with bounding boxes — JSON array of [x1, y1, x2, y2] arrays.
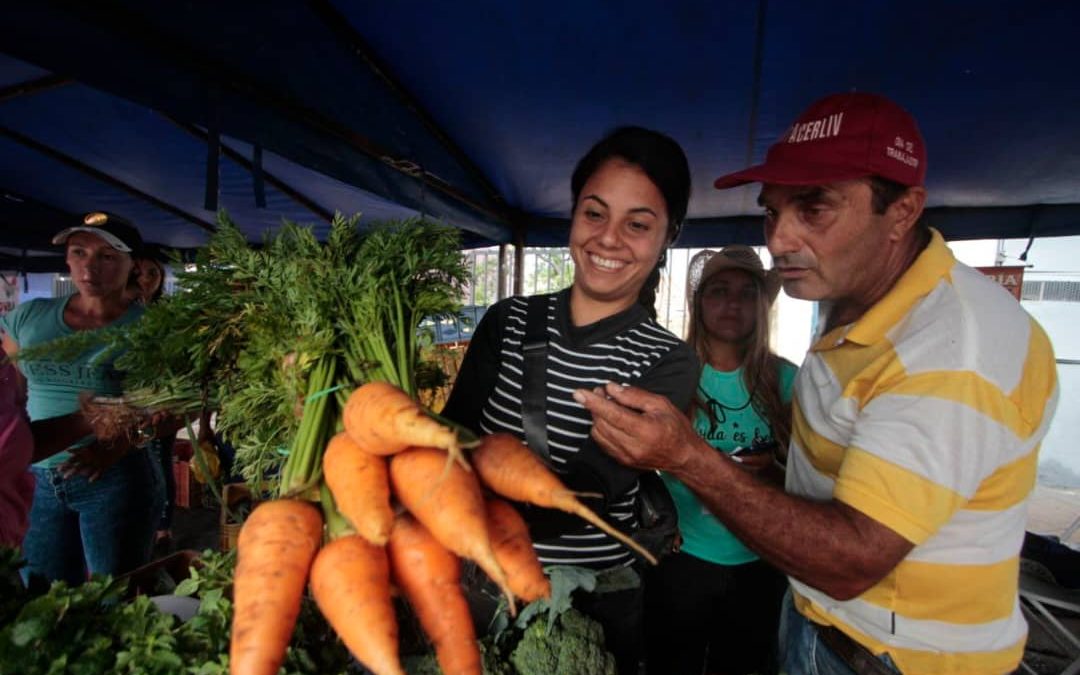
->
[[522, 296, 678, 558]]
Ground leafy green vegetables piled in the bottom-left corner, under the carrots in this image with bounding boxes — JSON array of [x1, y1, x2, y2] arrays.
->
[[0, 550, 361, 675]]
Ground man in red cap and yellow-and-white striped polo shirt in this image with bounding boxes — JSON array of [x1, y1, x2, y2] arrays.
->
[[577, 94, 1057, 675]]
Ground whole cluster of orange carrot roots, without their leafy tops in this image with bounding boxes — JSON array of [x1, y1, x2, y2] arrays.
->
[[230, 381, 651, 675]]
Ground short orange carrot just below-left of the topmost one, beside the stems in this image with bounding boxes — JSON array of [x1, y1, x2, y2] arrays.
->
[[323, 433, 394, 546]]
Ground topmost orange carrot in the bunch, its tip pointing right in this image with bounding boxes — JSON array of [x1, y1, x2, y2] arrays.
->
[[341, 382, 467, 465]]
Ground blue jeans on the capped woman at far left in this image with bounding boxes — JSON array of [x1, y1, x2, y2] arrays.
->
[[23, 449, 165, 584]]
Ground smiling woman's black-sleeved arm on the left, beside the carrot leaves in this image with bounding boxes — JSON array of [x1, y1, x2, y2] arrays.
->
[[440, 303, 503, 433]]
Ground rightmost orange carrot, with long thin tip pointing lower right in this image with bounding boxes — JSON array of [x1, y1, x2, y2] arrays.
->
[[472, 433, 657, 565]]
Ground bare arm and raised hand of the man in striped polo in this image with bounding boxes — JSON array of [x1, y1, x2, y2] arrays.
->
[[575, 384, 914, 600]]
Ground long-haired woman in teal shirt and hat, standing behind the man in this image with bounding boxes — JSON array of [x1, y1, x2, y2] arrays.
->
[[645, 245, 796, 675]]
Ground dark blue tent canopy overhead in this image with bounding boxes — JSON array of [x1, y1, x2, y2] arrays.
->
[[0, 0, 1080, 269]]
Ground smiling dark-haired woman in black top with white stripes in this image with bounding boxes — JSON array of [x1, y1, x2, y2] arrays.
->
[[442, 127, 698, 673]]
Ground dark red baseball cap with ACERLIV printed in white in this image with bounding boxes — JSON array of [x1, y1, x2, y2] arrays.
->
[[714, 93, 927, 190]]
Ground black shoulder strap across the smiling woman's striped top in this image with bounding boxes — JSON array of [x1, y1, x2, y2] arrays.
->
[[522, 295, 551, 462]]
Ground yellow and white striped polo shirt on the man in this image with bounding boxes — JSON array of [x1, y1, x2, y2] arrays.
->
[[787, 231, 1057, 675]]
